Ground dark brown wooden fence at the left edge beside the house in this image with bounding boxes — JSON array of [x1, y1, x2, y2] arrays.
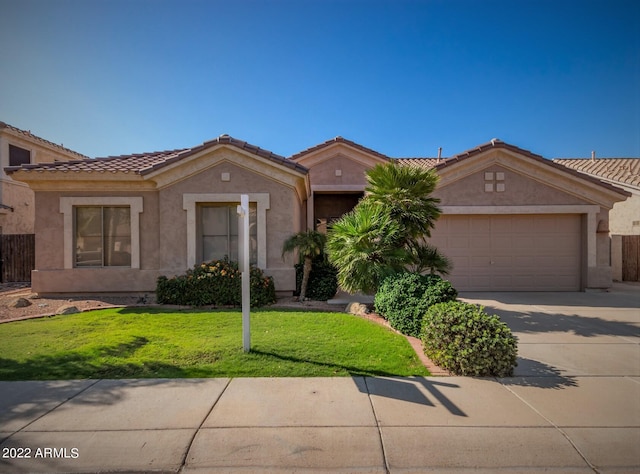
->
[[0, 234, 36, 283]]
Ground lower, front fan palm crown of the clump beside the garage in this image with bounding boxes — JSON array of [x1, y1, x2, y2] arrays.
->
[[327, 200, 407, 293]]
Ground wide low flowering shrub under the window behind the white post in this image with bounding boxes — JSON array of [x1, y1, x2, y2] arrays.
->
[[156, 258, 276, 307]]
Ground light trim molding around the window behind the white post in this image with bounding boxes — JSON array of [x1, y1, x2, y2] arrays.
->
[[182, 193, 270, 269]]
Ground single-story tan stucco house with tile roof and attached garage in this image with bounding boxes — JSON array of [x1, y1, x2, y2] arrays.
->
[[7, 135, 629, 294]]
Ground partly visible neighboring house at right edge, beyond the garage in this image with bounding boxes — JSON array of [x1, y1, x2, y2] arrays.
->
[[553, 154, 640, 281]]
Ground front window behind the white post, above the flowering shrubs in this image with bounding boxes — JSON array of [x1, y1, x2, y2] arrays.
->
[[198, 203, 258, 265]]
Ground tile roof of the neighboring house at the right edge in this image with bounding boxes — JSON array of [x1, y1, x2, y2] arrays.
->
[[553, 158, 640, 189]]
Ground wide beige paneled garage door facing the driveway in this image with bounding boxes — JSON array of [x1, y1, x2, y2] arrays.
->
[[431, 214, 581, 291]]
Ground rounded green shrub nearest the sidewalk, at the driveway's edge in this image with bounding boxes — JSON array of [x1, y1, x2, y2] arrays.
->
[[422, 301, 518, 377]]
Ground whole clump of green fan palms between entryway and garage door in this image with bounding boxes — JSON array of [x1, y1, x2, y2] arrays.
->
[[327, 162, 451, 293]]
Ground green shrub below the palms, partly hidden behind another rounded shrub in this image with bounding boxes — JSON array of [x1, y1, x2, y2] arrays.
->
[[374, 272, 458, 337]]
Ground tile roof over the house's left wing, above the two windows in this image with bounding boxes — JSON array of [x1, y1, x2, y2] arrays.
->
[[5, 135, 308, 175]]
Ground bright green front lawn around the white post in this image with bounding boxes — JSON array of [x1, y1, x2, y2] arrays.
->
[[0, 308, 429, 380]]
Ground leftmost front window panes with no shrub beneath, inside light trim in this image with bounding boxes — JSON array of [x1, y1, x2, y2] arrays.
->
[[74, 206, 131, 267]]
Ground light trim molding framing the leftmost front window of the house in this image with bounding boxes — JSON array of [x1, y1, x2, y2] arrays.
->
[[60, 196, 143, 269]]
